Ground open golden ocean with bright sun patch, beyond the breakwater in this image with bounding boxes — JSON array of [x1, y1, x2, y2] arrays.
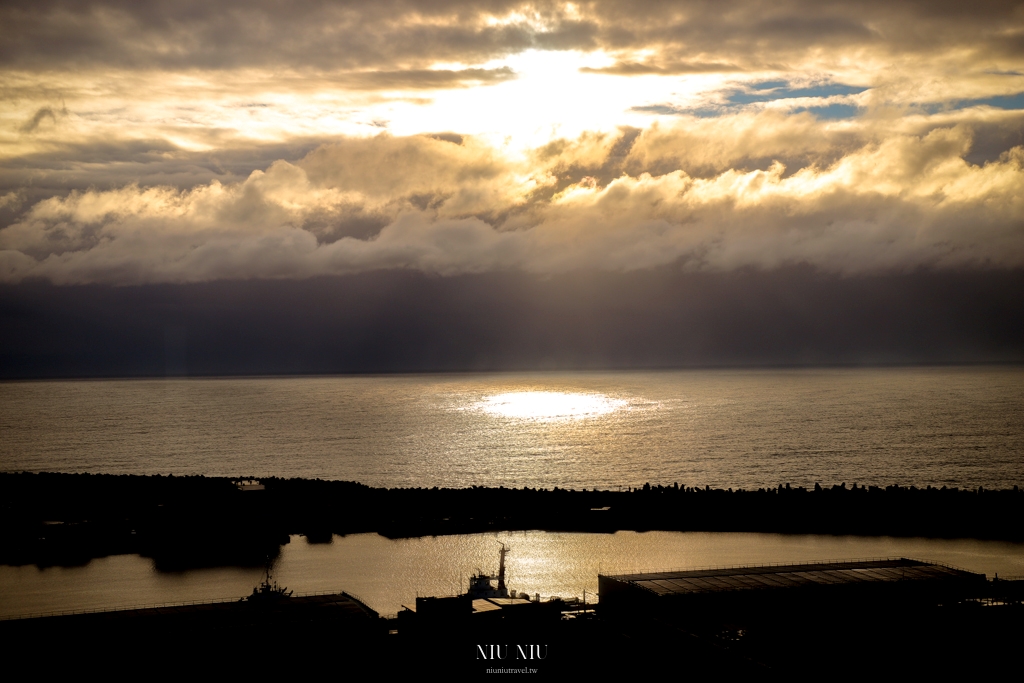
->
[[0, 367, 1024, 488]]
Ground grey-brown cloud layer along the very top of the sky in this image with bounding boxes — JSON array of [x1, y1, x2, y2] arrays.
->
[[0, 0, 1024, 70]]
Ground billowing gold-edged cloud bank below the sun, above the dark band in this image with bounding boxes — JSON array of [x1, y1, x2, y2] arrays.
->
[[0, 113, 1024, 284]]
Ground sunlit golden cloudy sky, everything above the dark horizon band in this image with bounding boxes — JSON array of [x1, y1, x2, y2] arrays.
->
[[0, 0, 1024, 285]]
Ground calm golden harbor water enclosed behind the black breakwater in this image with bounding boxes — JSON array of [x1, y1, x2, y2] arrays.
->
[[0, 531, 1024, 616]]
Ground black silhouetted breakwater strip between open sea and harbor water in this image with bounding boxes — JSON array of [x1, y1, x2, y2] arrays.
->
[[0, 473, 1024, 569]]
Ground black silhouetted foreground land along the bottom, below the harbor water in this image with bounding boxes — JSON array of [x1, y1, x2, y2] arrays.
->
[[0, 560, 1024, 680]]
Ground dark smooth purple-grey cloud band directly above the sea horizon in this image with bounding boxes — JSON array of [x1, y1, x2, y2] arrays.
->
[[0, 268, 1024, 378]]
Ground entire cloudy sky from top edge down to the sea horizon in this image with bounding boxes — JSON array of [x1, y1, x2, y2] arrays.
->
[[0, 0, 1024, 376]]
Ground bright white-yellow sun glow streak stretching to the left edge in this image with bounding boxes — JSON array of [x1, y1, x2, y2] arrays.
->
[[0, 49, 749, 154]]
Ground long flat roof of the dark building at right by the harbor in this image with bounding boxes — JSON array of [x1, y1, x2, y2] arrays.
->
[[606, 558, 985, 595]]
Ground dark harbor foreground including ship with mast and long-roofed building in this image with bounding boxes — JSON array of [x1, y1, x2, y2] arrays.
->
[[0, 543, 1024, 675]]
